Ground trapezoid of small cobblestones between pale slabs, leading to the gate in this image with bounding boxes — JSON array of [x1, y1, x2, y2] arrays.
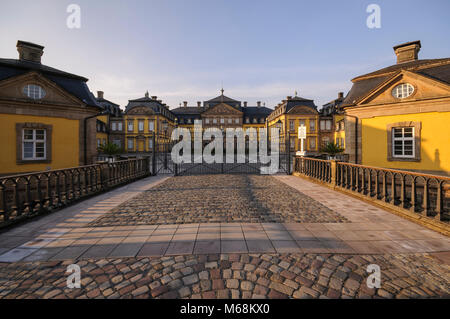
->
[[90, 175, 348, 227]]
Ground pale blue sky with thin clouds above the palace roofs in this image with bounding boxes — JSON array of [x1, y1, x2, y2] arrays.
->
[[0, 0, 450, 107]]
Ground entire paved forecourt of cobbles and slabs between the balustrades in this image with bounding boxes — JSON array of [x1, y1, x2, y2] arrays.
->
[[0, 175, 450, 299]]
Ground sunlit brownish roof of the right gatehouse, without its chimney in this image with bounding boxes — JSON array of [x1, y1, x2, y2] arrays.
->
[[342, 58, 450, 106]]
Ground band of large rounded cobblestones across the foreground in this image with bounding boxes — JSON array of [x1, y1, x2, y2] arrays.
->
[[0, 253, 450, 299]]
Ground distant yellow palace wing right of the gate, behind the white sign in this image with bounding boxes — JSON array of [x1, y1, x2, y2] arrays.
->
[[267, 96, 319, 155]]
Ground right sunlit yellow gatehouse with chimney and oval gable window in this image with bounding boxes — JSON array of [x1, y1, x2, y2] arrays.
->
[[343, 41, 450, 175]]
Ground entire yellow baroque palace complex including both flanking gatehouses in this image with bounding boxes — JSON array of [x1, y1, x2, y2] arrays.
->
[[0, 41, 450, 175]]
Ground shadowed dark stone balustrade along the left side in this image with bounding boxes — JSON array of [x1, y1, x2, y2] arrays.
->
[[0, 158, 151, 228]]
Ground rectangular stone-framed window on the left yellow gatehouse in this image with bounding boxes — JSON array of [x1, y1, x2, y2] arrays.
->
[[22, 129, 46, 160]]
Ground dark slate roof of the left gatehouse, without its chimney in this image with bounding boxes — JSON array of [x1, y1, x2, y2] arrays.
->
[[0, 59, 99, 107]]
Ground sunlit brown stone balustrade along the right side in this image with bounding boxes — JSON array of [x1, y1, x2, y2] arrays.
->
[[294, 157, 450, 222]]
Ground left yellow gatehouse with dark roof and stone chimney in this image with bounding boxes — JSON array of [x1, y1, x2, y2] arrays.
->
[[0, 41, 101, 175]]
